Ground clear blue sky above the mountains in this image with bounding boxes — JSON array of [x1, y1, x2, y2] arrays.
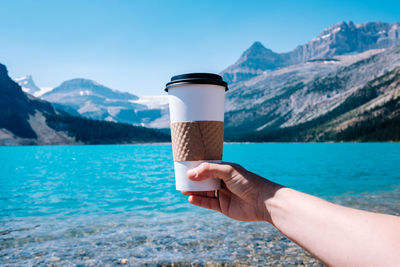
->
[[0, 0, 400, 96]]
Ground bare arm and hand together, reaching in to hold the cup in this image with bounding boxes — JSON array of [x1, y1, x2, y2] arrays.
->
[[182, 163, 400, 266]]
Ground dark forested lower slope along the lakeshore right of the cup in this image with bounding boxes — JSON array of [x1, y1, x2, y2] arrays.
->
[[227, 63, 400, 142]]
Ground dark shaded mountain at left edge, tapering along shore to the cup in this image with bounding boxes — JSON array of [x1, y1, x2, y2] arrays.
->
[[0, 64, 170, 145]]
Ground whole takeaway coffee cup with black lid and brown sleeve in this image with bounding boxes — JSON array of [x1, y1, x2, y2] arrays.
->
[[165, 73, 228, 191]]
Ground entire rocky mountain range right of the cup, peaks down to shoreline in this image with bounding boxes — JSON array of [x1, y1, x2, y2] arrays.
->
[[222, 19, 400, 141]]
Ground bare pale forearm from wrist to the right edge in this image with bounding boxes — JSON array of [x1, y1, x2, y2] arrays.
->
[[265, 188, 400, 266]]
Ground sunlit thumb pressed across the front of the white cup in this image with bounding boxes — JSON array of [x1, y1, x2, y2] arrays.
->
[[187, 162, 234, 181]]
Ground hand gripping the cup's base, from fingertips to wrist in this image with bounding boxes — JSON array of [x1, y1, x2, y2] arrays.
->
[[182, 162, 281, 222]]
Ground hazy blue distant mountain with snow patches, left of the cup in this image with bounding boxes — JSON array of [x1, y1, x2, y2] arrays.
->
[[41, 79, 169, 128]]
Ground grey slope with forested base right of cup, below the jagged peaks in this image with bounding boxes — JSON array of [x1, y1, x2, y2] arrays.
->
[[225, 45, 400, 141]]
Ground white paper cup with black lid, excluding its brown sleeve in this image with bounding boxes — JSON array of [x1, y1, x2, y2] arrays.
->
[[165, 73, 227, 191]]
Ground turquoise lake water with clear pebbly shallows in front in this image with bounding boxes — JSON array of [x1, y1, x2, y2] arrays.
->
[[0, 143, 400, 266]]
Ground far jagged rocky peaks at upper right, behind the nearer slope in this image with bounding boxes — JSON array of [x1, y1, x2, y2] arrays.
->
[[221, 21, 400, 83]]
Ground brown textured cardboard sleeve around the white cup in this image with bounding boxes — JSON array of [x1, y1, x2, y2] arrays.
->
[[171, 121, 224, 161]]
